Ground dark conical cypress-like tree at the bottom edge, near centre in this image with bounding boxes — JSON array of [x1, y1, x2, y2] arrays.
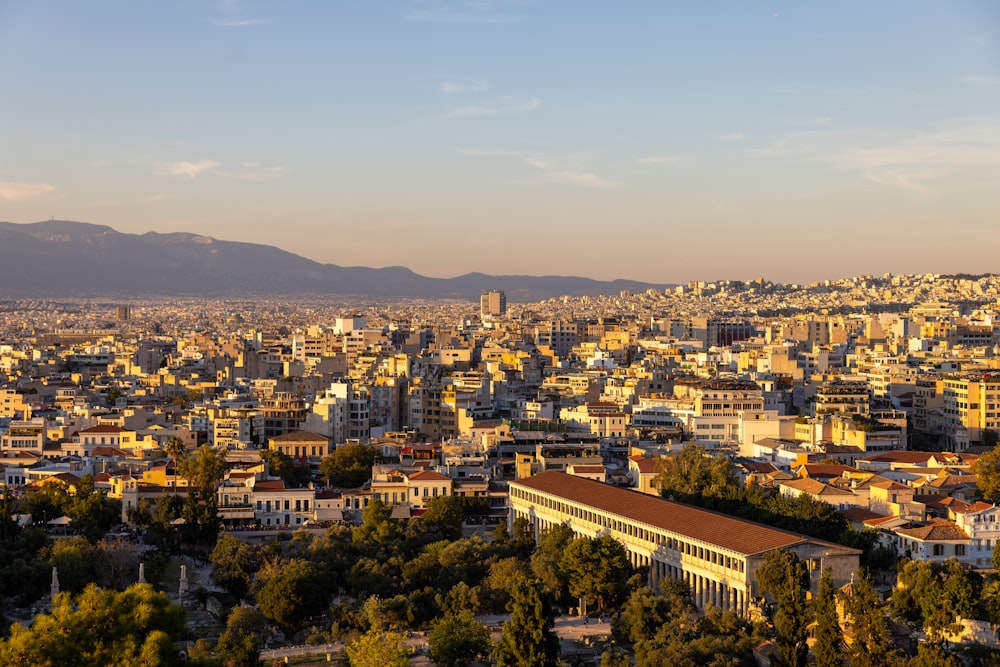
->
[[493, 581, 559, 667]]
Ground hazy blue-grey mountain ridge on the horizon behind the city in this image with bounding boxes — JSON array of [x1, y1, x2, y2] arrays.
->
[[0, 220, 667, 301]]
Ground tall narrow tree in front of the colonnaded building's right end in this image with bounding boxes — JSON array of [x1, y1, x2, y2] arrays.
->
[[757, 549, 809, 667]]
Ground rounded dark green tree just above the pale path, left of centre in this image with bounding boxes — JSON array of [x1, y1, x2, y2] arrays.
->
[[257, 558, 330, 631]]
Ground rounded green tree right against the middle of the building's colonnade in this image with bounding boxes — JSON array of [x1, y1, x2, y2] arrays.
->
[[562, 535, 633, 609]]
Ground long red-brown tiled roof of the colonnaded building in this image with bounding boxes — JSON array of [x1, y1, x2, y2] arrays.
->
[[510, 470, 860, 556]]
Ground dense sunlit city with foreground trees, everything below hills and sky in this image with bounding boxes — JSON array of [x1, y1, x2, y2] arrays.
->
[[0, 274, 1000, 665]]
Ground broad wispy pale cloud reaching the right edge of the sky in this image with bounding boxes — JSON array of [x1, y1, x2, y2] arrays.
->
[[757, 118, 1000, 194]]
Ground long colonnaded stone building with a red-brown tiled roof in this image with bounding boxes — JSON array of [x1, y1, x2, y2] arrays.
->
[[510, 471, 861, 615]]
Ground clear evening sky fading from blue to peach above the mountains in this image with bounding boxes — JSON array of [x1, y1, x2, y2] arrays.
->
[[0, 0, 1000, 283]]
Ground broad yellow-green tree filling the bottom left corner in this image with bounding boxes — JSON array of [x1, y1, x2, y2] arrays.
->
[[0, 584, 184, 667]]
